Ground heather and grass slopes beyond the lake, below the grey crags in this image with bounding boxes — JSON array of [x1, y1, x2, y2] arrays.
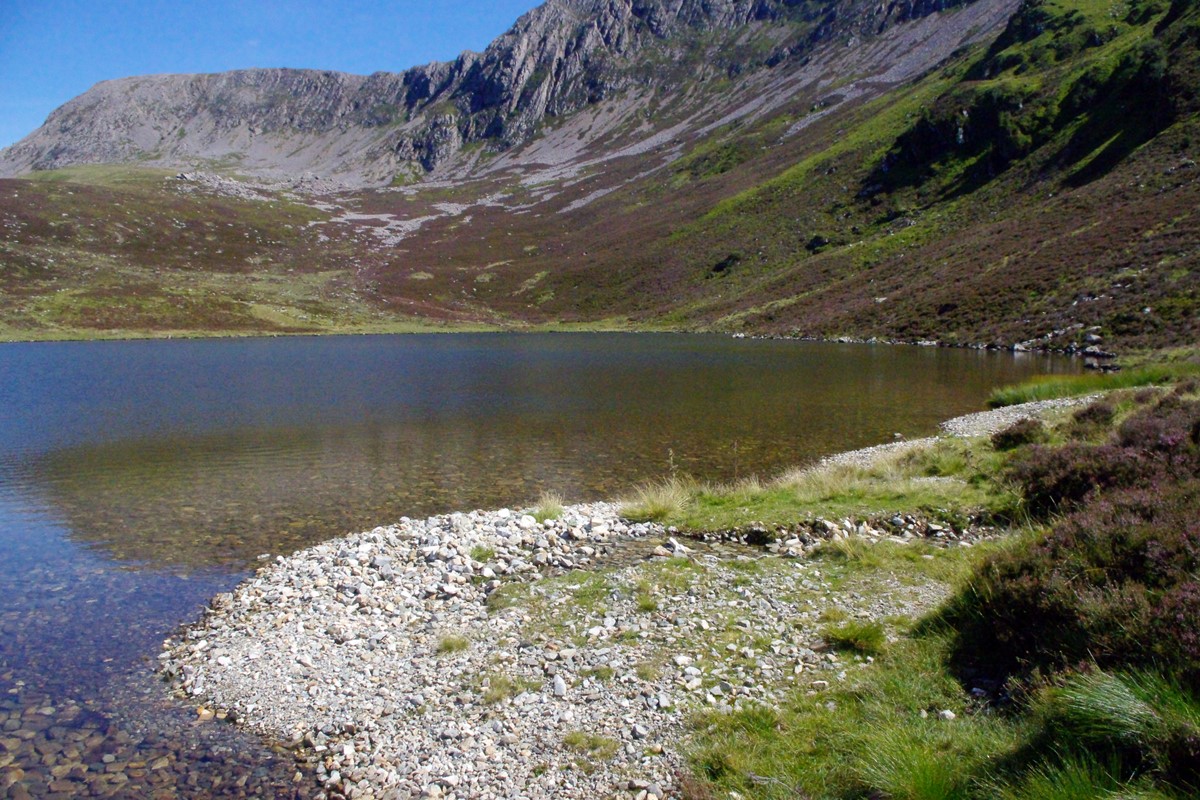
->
[[0, 0, 1200, 349]]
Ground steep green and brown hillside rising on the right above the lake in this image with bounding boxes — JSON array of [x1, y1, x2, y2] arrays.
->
[[547, 0, 1200, 345]]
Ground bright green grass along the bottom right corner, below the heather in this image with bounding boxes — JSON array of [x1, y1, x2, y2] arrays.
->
[[688, 634, 1200, 800]]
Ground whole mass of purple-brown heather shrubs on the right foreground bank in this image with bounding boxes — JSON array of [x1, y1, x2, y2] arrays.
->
[[944, 395, 1200, 687]]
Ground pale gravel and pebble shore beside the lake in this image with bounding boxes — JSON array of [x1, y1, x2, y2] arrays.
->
[[160, 398, 1091, 800]]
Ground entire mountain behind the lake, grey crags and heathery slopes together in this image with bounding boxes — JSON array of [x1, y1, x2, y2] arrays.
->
[[0, 0, 1200, 351]]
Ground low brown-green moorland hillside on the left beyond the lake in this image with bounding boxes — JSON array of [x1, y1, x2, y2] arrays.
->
[[0, 167, 511, 338]]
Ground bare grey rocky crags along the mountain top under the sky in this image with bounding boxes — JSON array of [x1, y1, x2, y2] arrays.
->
[[0, 0, 985, 185]]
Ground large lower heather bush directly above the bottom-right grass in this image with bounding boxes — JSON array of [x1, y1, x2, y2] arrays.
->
[[948, 481, 1200, 685]]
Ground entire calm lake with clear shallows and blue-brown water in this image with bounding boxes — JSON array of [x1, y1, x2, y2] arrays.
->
[[0, 335, 1075, 796]]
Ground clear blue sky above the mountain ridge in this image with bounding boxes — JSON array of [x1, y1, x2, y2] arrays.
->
[[0, 0, 540, 148]]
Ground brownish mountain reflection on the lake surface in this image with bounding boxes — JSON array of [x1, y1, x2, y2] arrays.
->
[[12, 337, 1070, 572]]
